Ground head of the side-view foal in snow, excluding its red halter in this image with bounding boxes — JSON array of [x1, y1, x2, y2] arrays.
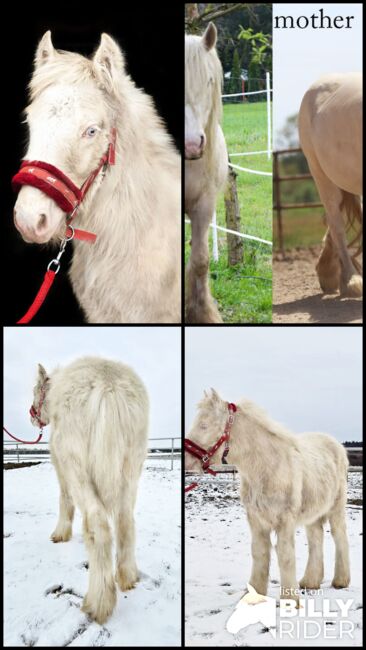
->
[[184, 388, 228, 472]]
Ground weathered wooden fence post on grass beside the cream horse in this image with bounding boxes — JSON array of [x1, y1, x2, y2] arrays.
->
[[225, 167, 244, 266]]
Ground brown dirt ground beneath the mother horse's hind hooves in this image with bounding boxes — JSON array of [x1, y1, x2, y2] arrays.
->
[[273, 246, 362, 323]]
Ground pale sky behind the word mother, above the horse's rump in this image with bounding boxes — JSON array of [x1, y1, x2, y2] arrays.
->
[[273, 3, 362, 146]]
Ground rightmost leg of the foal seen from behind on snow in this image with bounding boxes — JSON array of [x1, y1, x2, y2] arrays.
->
[[115, 468, 139, 591]]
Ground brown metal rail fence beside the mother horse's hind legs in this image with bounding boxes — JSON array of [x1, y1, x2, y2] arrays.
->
[[273, 148, 323, 256]]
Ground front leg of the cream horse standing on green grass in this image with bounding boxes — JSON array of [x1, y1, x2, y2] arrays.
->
[[186, 198, 222, 323]]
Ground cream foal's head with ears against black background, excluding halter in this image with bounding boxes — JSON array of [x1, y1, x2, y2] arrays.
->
[[14, 31, 124, 243]]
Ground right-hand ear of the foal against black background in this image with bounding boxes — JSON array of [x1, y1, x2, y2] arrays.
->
[[93, 34, 125, 92]]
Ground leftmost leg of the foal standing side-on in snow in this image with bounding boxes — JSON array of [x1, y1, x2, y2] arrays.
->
[[248, 513, 271, 596]]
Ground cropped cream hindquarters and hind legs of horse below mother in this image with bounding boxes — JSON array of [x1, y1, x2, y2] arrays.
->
[[299, 73, 362, 297]]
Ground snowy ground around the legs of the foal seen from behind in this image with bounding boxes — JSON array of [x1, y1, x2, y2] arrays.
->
[[4, 461, 181, 647]]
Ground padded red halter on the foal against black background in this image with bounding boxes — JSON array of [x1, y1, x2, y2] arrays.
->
[[12, 127, 117, 243]]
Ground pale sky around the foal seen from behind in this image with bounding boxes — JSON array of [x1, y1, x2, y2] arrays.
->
[[4, 327, 181, 445]]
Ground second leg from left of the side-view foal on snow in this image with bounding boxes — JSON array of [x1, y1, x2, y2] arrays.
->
[[276, 520, 299, 604]]
